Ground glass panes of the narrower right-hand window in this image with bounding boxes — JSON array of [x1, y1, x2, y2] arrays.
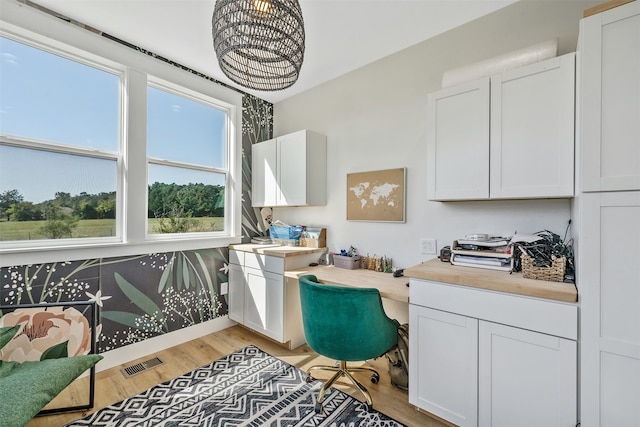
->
[[147, 84, 228, 235]]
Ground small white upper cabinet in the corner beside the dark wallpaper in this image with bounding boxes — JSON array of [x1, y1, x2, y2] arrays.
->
[[251, 130, 327, 206]]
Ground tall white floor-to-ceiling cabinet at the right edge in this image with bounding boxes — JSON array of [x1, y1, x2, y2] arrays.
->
[[576, 1, 640, 427]]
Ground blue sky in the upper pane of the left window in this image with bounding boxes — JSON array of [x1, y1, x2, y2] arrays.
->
[[0, 38, 120, 152]]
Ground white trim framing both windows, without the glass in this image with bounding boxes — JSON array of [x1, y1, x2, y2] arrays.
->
[[0, 0, 242, 266]]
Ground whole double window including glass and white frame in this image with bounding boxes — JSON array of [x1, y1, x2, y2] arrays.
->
[[0, 6, 242, 258]]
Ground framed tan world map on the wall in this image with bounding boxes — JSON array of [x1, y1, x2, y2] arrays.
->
[[347, 168, 406, 222]]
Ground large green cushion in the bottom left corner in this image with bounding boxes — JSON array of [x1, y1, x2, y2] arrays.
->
[[0, 354, 102, 427]]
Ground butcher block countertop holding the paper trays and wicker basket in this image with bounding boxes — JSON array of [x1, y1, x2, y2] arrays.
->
[[404, 258, 578, 302]]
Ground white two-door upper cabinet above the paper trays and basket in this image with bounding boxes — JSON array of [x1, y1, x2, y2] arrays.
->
[[427, 53, 575, 200]]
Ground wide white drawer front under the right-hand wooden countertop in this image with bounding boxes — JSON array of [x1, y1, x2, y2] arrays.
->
[[409, 279, 578, 340]]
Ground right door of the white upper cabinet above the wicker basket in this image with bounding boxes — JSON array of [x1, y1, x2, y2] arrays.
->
[[489, 53, 575, 198]]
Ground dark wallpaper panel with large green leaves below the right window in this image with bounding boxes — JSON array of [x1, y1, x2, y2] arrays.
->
[[99, 248, 228, 351]]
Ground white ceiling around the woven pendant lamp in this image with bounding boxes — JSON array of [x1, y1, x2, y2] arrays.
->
[[32, 0, 516, 103]]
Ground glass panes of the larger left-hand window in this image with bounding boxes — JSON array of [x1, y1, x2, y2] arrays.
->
[[0, 37, 120, 243]]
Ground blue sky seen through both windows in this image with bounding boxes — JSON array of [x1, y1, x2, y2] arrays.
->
[[0, 37, 226, 203]]
